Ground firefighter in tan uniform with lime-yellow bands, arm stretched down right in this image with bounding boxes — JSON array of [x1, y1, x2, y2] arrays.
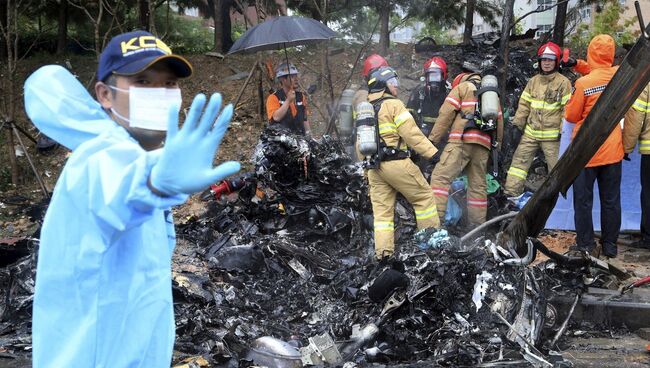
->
[[368, 67, 440, 259]]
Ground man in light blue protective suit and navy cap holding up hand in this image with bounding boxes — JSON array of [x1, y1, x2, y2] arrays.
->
[[25, 31, 239, 368]]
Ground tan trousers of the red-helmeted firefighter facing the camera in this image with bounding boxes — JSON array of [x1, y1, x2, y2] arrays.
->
[[504, 134, 560, 197]]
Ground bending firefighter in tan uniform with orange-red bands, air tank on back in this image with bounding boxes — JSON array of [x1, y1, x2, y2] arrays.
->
[[429, 73, 503, 226]]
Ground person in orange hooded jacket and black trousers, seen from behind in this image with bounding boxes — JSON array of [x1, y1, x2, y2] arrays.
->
[[564, 34, 624, 258]]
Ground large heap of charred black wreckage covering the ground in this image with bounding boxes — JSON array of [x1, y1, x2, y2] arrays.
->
[[165, 129, 624, 367]]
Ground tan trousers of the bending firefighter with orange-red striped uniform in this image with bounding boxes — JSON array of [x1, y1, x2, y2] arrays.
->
[[431, 141, 490, 225]]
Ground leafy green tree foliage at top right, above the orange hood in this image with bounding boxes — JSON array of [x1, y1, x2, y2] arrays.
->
[[569, 0, 637, 50]]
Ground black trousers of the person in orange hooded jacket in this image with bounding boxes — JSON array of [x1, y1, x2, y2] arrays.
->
[[573, 162, 624, 255]]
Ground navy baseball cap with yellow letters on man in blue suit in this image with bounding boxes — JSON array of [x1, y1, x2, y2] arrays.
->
[[97, 31, 192, 82]]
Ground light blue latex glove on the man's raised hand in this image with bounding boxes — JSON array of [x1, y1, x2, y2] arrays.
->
[[150, 93, 240, 195]]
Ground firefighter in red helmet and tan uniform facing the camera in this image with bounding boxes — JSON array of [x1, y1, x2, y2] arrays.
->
[[504, 42, 571, 197]]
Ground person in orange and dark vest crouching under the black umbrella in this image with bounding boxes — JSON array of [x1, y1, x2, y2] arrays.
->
[[266, 63, 311, 136]]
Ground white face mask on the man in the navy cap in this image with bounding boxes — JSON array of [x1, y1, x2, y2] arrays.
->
[[110, 86, 183, 131]]
